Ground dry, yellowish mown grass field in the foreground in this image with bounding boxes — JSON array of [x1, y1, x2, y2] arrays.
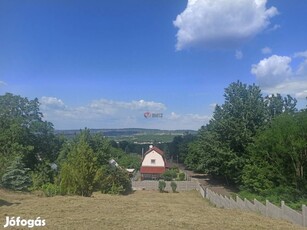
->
[[0, 190, 304, 230]]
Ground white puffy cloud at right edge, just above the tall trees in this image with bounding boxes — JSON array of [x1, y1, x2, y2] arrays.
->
[[251, 52, 307, 98]]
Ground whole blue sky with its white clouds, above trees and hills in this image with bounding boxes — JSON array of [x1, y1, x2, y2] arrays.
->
[[0, 0, 307, 130]]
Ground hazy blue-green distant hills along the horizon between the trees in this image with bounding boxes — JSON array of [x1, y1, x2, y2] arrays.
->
[[55, 128, 197, 143]]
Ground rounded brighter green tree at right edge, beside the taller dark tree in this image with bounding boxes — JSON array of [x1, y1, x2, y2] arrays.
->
[[243, 111, 307, 192]]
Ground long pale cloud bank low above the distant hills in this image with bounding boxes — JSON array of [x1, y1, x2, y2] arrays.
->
[[40, 96, 210, 130]]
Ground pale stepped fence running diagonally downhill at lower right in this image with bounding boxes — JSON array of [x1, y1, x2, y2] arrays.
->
[[197, 184, 307, 227]]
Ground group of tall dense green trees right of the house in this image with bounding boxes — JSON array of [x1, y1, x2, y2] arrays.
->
[[181, 81, 307, 208]]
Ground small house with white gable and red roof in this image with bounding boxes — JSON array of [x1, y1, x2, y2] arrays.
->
[[140, 145, 167, 180]]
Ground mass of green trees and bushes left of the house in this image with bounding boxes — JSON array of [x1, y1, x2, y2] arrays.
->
[[0, 93, 140, 196]]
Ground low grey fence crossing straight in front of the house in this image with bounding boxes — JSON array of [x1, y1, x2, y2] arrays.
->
[[132, 180, 197, 191]]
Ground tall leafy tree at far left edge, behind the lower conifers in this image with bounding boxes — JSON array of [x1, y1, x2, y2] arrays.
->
[[0, 93, 61, 175]]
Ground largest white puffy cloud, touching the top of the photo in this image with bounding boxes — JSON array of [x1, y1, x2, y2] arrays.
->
[[173, 0, 278, 50]]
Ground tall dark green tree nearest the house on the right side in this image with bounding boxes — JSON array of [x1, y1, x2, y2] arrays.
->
[[185, 81, 267, 184]]
